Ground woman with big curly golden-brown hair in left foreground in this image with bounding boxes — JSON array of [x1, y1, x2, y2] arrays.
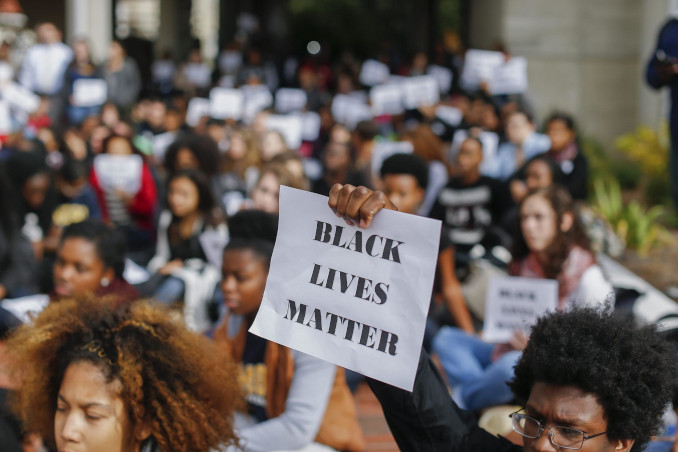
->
[[8, 299, 241, 452]]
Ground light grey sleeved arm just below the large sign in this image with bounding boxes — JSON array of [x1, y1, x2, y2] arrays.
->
[[239, 351, 336, 451]]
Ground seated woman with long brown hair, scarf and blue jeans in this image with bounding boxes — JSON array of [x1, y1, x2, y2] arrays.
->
[[433, 186, 613, 411]]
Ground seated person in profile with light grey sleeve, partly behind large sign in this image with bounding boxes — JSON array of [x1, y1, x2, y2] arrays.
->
[[212, 210, 364, 452]]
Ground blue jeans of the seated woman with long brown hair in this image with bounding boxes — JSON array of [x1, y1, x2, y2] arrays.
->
[[433, 326, 521, 411]]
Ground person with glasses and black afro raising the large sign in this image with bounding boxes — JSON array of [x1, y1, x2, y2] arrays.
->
[[328, 185, 675, 452]]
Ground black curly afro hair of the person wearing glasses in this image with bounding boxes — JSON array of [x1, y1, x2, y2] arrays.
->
[[509, 308, 674, 452]]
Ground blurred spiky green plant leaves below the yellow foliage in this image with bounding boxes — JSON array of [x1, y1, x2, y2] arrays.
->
[[592, 178, 673, 256]]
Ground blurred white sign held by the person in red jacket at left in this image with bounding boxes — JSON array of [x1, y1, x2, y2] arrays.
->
[[94, 154, 143, 196]]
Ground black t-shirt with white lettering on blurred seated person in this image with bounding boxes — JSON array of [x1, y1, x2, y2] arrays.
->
[[430, 176, 513, 252]]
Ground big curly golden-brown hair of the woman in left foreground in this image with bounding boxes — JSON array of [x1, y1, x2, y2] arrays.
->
[[8, 298, 242, 452]]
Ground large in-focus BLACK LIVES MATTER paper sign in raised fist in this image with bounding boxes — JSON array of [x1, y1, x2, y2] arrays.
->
[[250, 186, 440, 391]]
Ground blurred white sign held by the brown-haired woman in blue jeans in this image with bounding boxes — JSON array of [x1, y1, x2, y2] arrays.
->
[[483, 276, 558, 343]]
